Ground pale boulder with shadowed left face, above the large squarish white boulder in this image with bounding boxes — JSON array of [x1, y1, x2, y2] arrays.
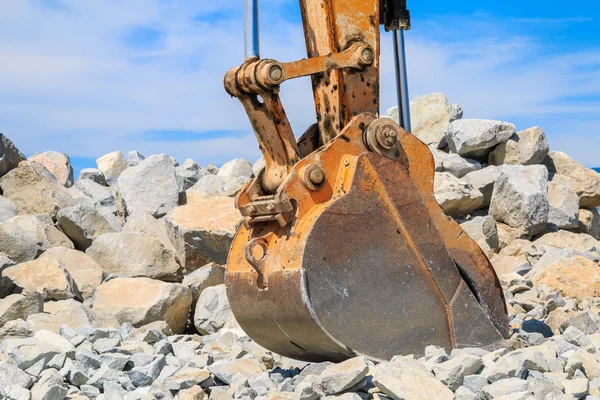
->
[[489, 126, 550, 165]]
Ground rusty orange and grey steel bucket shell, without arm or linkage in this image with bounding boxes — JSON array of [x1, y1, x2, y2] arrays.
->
[[226, 114, 507, 361]]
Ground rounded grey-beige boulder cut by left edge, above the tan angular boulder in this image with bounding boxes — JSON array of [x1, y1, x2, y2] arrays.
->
[[0, 214, 74, 263]]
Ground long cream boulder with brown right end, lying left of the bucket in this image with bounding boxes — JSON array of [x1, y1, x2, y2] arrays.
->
[[93, 278, 192, 333]]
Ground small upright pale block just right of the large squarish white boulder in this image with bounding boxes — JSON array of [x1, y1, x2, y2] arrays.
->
[[548, 182, 579, 229]]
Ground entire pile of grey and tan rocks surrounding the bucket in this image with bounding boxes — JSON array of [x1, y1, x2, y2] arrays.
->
[[0, 93, 600, 400]]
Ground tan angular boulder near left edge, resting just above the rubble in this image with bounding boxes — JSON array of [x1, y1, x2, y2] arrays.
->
[[2, 258, 81, 300]]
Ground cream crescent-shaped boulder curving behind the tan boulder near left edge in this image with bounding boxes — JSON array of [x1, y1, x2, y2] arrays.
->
[[40, 247, 104, 299]]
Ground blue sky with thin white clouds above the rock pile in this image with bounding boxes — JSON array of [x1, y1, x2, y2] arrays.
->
[[0, 0, 600, 177]]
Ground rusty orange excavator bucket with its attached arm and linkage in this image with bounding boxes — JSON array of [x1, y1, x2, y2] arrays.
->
[[225, 0, 509, 361]]
